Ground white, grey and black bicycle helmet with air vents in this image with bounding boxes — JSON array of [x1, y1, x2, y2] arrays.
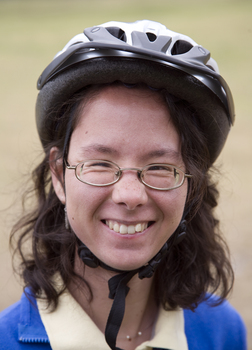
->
[[36, 20, 234, 162]]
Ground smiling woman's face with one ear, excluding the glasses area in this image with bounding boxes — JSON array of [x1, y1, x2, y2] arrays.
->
[[52, 86, 187, 270]]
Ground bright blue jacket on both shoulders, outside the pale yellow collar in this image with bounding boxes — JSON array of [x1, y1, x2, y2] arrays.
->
[[0, 292, 247, 350]]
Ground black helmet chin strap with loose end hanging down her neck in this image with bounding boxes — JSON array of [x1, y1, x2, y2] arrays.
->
[[77, 220, 186, 350]]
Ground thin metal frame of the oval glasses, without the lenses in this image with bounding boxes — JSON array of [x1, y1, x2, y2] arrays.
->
[[64, 159, 193, 191]]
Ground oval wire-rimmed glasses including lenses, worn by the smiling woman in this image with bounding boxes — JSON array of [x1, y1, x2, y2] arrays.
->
[[65, 159, 192, 191]]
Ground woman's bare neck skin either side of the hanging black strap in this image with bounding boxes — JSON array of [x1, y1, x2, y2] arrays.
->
[[69, 253, 158, 350]]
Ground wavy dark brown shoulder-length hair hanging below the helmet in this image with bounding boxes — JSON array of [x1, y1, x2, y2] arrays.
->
[[10, 83, 234, 309]]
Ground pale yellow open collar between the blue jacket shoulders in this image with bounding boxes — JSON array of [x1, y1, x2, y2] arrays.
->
[[37, 290, 188, 350]]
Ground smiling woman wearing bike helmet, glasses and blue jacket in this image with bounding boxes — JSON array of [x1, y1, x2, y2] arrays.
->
[[0, 21, 246, 350]]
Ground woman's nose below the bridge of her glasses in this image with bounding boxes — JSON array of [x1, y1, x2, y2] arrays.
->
[[112, 170, 148, 210]]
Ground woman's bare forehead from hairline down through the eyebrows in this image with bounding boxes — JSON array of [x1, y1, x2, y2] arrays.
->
[[70, 86, 180, 164]]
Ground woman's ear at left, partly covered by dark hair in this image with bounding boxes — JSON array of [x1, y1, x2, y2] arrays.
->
[[49, 147, 66, 204]]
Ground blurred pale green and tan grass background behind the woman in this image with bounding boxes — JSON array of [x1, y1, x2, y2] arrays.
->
[[0, 0, 252, 350]]
